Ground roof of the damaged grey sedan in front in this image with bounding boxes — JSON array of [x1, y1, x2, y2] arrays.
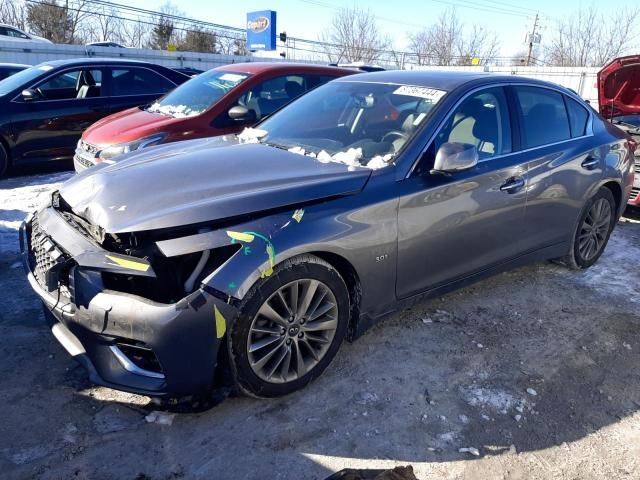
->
[[337, 70, 568, 91]]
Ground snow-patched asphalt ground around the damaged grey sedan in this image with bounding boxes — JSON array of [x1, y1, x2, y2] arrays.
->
[[0, 173, 640, 480]]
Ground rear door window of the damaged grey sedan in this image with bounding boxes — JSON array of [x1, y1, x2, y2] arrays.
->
[[514, 86, 571, 149]]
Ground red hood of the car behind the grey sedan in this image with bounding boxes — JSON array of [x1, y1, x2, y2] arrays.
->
[[82, 107, 188, 147]]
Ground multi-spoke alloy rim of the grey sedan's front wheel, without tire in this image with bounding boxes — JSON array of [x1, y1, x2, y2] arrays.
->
[[247, 279, 338, 383]]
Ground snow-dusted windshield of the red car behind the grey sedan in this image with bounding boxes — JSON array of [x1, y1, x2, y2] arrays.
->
[[147, 70, 249, 117]]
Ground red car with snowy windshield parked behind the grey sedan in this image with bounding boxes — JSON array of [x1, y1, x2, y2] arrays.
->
[[74, 63, 357, 171]]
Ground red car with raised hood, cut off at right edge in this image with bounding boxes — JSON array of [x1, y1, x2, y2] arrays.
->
[[598, 55, 640, 206]]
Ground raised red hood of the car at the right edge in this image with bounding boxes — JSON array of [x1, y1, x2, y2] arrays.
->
[[598, 55, 640, 118]]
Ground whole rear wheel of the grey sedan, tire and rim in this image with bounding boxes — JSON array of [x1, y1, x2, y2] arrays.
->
[[562, 187, 616, 269]]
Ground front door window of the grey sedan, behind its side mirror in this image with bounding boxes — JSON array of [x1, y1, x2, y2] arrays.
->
[[433, 87, 511, 159]]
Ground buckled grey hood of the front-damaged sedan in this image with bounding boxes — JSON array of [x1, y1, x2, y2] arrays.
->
[[60, 136, 371, 233]]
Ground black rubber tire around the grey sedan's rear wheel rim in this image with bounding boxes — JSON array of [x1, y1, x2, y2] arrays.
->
[[559, 187, 617, 270]]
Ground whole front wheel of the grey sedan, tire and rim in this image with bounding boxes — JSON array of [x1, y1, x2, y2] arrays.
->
[[229, 255, 350, 397]]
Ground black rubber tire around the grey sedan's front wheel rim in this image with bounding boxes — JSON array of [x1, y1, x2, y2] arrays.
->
[[228, 255, 350, 397]]
